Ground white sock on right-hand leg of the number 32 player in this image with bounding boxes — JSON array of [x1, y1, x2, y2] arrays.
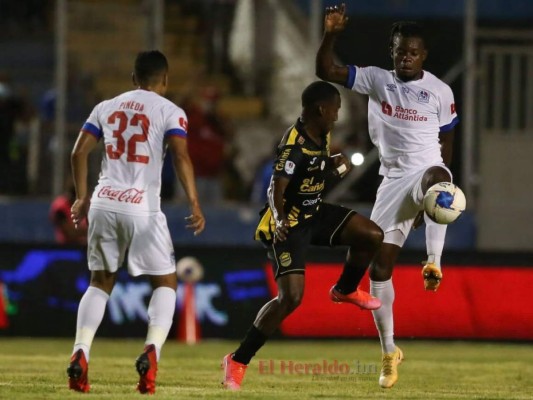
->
[[145, 286, 176, 361]]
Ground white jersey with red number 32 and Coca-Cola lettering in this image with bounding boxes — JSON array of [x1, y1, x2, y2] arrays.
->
[[82, 89, 187, 215]]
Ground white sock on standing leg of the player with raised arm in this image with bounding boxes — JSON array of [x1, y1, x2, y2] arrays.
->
[[370, 278, 396, 353]]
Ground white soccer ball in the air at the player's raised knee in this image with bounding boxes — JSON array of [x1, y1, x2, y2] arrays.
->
[[424, 182, 466, 225]]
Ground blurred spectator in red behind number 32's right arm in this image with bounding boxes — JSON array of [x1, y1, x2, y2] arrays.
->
[[181, 88, 242, 203]]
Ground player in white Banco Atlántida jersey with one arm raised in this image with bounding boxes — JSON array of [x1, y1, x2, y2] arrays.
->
[[316, 4, 458, 388]]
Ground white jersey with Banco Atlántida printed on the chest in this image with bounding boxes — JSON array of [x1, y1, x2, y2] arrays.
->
[[346, 65, 459, 177]]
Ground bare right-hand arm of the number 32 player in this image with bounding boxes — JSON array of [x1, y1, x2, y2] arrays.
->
[[168, 136, 205, 236]]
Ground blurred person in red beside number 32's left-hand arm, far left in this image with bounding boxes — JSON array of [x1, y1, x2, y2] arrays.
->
[[49, 178, 87, 245]]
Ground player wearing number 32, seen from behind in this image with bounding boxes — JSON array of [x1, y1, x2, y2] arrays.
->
[[67, 50, 205, 394]]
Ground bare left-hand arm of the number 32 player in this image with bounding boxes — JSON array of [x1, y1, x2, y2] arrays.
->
[[70, 131, 98, 229]]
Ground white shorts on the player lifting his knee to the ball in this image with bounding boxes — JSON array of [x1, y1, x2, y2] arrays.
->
[[370, 164, 453, 247]]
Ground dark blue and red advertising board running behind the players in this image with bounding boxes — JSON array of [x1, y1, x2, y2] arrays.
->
[[0, 244, 533, 340]]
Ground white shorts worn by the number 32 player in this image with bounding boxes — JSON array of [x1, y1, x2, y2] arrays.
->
[[87, 208, 176, 276]]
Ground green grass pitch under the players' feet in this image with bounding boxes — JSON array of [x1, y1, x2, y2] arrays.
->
[[0, 337, 533, 400]]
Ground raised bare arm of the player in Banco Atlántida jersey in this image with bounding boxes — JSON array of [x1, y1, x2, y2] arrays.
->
[[315, 3, 348, 86]]
